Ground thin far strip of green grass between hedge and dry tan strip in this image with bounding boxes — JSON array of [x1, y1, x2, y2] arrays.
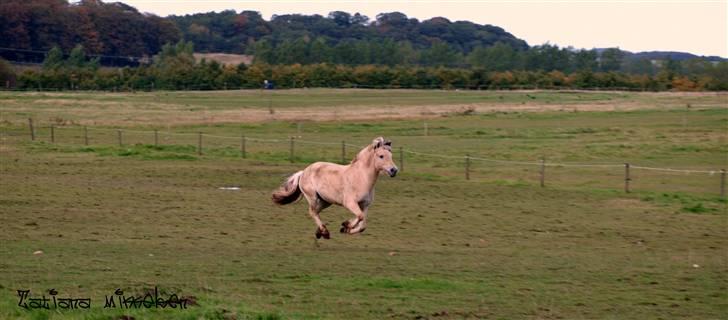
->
[[0, 89, 639, 108]]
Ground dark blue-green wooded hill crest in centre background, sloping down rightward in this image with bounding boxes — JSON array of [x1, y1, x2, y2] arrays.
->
[[170, 10, 528, 63]]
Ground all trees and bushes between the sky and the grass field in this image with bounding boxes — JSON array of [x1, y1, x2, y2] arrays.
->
[[0, 0, 727, 90]]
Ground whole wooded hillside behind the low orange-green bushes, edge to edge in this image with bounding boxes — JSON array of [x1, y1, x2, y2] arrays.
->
[[0, 0, 724, 70]]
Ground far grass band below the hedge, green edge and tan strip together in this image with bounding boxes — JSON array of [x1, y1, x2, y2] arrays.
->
[[0, 89, 726, 127]]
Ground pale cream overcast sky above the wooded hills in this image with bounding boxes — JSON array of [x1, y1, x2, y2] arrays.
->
[[122, 0, 728, 57]]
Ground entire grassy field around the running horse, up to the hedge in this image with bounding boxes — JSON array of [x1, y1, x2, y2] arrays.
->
[[0, 90, 728, 319]]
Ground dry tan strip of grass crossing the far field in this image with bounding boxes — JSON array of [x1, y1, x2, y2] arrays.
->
[[0, 101, 684, 126]]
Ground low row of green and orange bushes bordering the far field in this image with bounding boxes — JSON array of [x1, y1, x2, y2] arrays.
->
[[5, 41, 728, 91]]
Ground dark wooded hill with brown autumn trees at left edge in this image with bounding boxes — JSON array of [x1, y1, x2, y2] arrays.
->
[[0, 0, 181, 64]]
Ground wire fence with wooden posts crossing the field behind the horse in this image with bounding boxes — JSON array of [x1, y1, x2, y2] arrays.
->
[[28, 119, 726, 197]]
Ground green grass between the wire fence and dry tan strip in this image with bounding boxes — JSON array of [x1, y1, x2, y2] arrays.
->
[[7, 105, 728, 195]]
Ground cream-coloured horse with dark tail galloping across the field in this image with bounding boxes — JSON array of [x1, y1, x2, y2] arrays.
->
[[271, 137, 399, 239]]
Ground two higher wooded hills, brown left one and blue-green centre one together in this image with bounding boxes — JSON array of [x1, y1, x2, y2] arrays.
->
[[0, 0, 528, 65]]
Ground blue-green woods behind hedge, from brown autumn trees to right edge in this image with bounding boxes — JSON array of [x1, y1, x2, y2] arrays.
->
[[170, 10, 723, 75]]
